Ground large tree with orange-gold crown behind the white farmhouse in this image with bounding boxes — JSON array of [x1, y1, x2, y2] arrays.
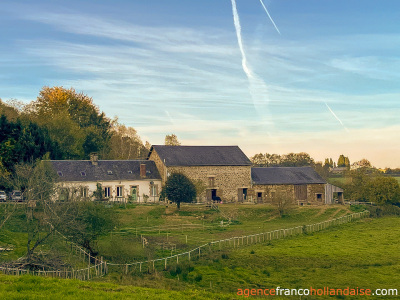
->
[[30, 87, 111, 159]]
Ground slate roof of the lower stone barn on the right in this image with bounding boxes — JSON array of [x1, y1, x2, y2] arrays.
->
[[251, 167, 326, 184]]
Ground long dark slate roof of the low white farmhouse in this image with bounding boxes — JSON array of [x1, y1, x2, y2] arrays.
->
[[50, 160, 161, 181]]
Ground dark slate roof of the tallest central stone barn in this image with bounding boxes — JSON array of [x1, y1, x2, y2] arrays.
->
[[148, 145, 251, 167]]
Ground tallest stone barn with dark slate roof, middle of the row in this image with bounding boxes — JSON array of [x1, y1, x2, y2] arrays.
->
[[147, 145, 251, 202]]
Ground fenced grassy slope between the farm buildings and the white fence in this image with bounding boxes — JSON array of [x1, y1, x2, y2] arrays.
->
[[98, 205, 351, 263]]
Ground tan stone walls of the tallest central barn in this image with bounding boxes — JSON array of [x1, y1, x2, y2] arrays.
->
[[149, 150, 251, 202]]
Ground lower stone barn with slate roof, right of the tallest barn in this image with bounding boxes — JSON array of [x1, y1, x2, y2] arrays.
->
[[251, 167, 326, 205]]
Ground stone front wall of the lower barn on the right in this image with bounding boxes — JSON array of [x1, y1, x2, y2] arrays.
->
[[250, 184, 325, 205]]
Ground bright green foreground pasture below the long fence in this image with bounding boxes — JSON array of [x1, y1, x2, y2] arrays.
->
[[0, 217, 400, 299]]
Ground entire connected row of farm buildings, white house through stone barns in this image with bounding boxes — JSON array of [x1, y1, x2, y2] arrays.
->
[[50, 145, 343, 205]]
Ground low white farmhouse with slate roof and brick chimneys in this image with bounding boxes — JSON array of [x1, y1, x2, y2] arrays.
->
[[50, 154, 161, 203]]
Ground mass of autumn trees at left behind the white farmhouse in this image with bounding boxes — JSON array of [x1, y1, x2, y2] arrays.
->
[[0, 87, 151, 189]]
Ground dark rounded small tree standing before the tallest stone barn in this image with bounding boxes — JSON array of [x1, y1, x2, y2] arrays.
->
[[164, 173, 196, 209]]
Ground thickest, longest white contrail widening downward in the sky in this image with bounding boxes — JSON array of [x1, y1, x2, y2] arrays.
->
[[231, 0, 270, 121]]
